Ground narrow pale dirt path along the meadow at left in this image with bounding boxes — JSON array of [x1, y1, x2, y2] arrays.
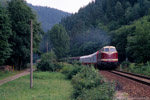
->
[[0, 69, 30, 85]]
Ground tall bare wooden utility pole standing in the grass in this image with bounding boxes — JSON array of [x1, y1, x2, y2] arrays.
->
[[30, 20, 33, 88]]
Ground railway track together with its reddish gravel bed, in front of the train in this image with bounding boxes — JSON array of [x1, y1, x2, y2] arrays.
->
[[100, 70, 150, 100]]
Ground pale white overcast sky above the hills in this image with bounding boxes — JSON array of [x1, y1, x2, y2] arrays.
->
[[26, 0, 94, 13]]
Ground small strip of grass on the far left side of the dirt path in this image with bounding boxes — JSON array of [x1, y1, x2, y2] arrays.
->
[[0, 71, 19, 80]]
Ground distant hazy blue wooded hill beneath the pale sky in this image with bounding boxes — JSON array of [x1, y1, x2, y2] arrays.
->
[[28, 4, 70, 32]]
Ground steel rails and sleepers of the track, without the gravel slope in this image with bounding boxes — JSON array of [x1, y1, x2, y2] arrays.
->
[[110, 70, 150, 86]]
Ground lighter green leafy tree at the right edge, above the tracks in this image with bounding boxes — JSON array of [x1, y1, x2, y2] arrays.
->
[[127, 16, 150, 63]]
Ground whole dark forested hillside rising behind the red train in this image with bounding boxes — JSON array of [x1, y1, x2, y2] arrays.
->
[[60, 0, 150, 63]]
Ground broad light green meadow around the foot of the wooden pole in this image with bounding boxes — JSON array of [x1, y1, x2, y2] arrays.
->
[[0, 72, 73, 100]]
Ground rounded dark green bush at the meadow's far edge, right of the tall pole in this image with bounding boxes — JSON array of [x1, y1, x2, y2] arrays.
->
[[37, 51, 56, 71]]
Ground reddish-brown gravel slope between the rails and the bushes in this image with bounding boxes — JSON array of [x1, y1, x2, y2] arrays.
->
[[100, 71, 150, 100]]
